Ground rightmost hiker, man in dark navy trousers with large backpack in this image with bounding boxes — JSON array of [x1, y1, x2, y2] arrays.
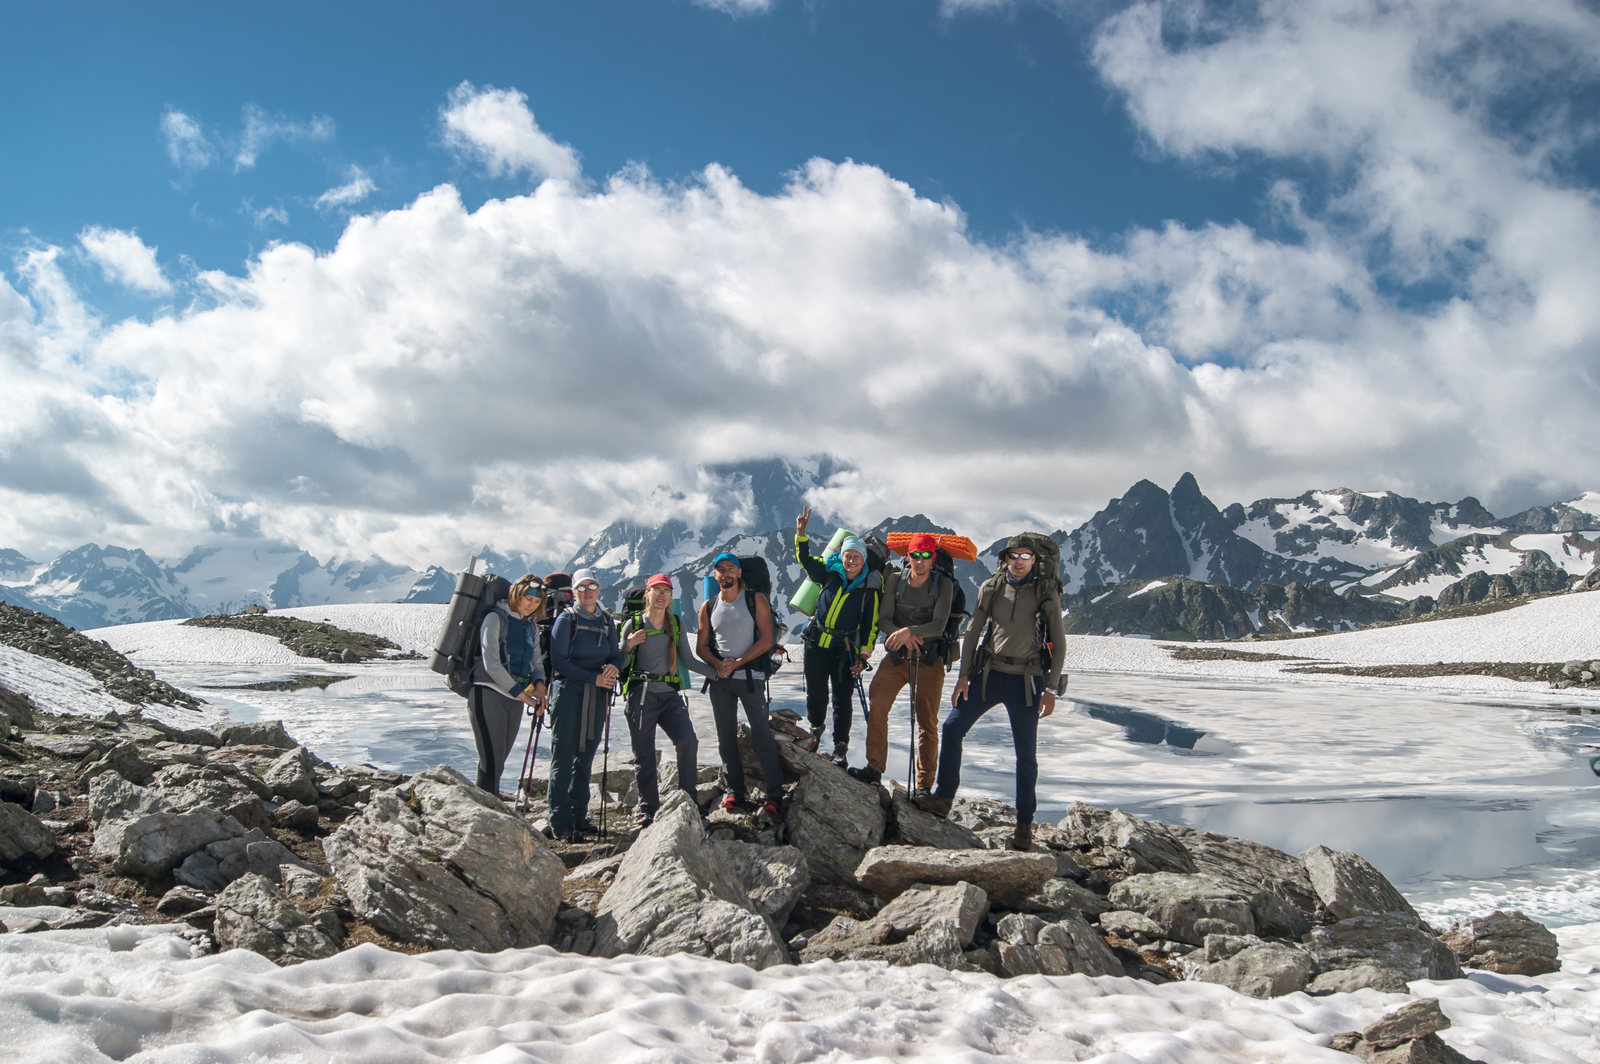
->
[[912, 536, 1064, 850]]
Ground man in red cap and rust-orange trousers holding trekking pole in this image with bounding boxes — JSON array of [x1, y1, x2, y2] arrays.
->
[[850, 533, 954, 790]]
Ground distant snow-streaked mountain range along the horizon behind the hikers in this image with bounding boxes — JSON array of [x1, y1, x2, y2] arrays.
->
[[0, 454, 1600, 629]]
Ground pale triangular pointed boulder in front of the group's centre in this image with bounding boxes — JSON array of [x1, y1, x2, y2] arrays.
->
[[594, 790, 789, 968]]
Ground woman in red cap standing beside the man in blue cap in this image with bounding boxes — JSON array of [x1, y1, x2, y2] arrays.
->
[[621, 573, 717, 827]]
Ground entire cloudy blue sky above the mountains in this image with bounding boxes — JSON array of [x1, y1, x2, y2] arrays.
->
[[0, 0, 1600, 565]]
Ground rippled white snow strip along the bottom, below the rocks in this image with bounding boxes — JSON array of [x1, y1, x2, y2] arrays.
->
[[0, 925, 1600, 1064]]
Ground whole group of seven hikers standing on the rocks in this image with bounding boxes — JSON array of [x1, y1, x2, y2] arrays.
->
[[467, 507, 1062, 850]]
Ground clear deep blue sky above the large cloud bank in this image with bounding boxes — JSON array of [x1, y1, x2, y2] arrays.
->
[[0, 0, 1266, 281]]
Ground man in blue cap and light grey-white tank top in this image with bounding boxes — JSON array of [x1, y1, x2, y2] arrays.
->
[[694, 554, 784, 819]]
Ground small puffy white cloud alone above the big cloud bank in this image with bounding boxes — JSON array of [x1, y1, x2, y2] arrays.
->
[[438, 82, 582, 181]]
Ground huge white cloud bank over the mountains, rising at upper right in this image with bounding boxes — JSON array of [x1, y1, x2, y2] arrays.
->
[[0, 5, 1600, 563]]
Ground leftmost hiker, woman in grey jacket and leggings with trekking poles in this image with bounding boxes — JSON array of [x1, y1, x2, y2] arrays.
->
[[467, 573, 546, 797]]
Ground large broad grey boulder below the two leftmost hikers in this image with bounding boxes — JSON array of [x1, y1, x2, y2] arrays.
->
[[323, 765, 565, 952]]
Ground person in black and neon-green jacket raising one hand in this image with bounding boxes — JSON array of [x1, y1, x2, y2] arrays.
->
[[795, 506, 883, 765]]
